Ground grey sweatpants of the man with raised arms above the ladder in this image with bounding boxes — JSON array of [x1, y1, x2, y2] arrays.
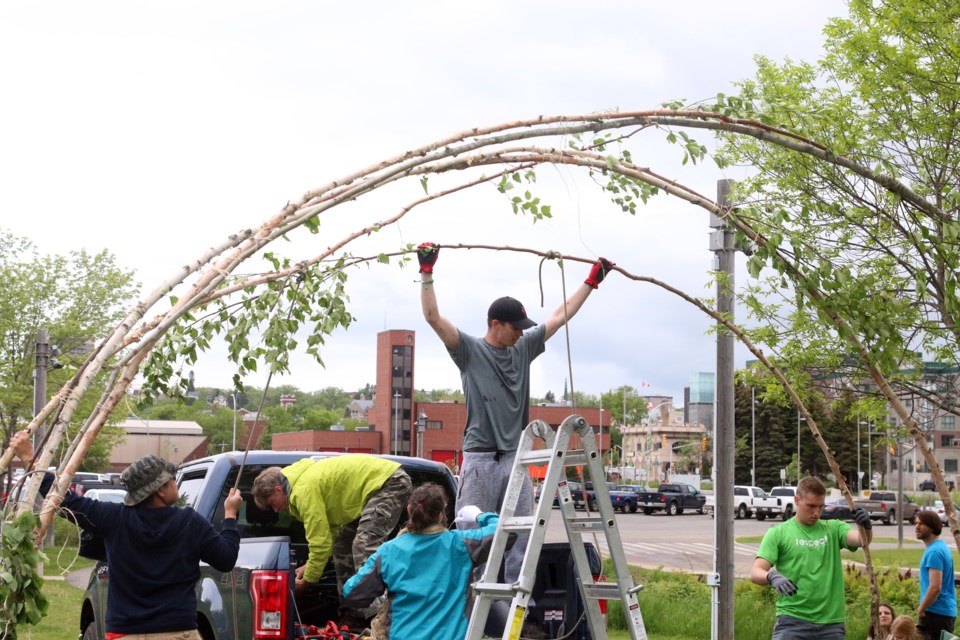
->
[[457, 451, 533, 582]]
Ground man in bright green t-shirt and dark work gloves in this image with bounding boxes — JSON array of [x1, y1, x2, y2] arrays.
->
[[750, 476, 873, 640]]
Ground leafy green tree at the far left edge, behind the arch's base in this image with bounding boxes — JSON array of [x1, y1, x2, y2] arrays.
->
[[0, 230, 136, 470]]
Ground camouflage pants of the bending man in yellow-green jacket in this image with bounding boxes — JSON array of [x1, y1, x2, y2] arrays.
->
[[333, 469, 413, 614]]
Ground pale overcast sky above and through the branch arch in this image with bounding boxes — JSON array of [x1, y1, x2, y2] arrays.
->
[[0, 0, 845, 403]]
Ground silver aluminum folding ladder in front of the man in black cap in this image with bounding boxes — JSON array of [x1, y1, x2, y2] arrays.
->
[[467, 414, 647, 640]]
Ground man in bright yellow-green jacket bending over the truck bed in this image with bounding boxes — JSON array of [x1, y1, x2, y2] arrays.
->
[[253, 455, 413, 622]]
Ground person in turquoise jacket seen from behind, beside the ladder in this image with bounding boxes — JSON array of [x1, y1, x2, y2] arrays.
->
[[343, 483, 499, 640]]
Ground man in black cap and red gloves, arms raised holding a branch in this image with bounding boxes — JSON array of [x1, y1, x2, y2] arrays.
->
[[417, 242, 614, 636]]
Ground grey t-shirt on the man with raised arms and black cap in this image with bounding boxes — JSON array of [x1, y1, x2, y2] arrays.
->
[[449, 324, 546, 451]]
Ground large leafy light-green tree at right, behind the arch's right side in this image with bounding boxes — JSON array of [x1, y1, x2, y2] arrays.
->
[[714, 0, 960, 480]]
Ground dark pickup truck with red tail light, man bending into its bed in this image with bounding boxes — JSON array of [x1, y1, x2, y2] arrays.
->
[[80, 451, 456, 640]]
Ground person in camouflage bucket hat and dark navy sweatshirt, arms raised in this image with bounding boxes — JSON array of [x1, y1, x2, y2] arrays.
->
[[10, 431, 243, 640]]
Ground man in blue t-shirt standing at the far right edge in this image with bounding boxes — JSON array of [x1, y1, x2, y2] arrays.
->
[[915, 511, 957, 640]]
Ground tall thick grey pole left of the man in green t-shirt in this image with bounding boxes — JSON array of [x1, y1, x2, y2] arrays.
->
[[707, 180, 736, 640]]
